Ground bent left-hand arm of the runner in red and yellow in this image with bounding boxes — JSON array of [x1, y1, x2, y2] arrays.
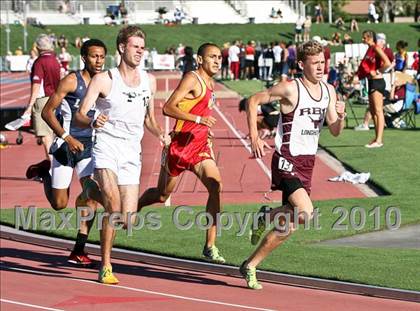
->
[[163, 72, 216, 127]]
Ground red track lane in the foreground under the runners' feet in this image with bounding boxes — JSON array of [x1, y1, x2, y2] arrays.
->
[[0, 239, 419, 311]]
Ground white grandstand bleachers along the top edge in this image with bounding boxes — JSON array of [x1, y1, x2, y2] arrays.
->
[[0, 0, 304, 25]]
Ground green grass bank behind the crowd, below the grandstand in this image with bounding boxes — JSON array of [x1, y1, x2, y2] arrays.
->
[[0, 23, 420, 56]]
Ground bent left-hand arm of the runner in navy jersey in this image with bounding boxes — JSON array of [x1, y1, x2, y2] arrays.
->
[[41, 73, 83, 152]]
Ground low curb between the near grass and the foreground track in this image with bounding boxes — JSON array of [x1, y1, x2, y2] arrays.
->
[[0, 225, 420, 302]]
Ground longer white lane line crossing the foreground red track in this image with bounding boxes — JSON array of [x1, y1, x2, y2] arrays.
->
[[1, 264, 275, 311]]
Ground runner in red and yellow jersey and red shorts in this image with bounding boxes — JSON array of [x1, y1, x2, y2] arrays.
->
[[138, 43, 225, 263]]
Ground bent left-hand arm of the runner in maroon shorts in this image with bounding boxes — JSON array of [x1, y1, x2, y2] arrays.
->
[[246, 81, 297, 158]]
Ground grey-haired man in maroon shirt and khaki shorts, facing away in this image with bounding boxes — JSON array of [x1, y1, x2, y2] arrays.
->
[[22, 34, 60, 179]]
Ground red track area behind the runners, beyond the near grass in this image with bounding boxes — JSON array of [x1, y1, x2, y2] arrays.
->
[[0, 72, 364, 208]]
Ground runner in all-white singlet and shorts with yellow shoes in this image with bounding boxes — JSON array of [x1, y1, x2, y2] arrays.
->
[[76, 26, 165, 284]]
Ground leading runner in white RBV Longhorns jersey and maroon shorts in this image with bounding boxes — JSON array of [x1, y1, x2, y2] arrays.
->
[[240, 41, 345, 289]]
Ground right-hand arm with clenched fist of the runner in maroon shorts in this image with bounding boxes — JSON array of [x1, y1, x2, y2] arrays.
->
[[327, 84, 346, 136]]
